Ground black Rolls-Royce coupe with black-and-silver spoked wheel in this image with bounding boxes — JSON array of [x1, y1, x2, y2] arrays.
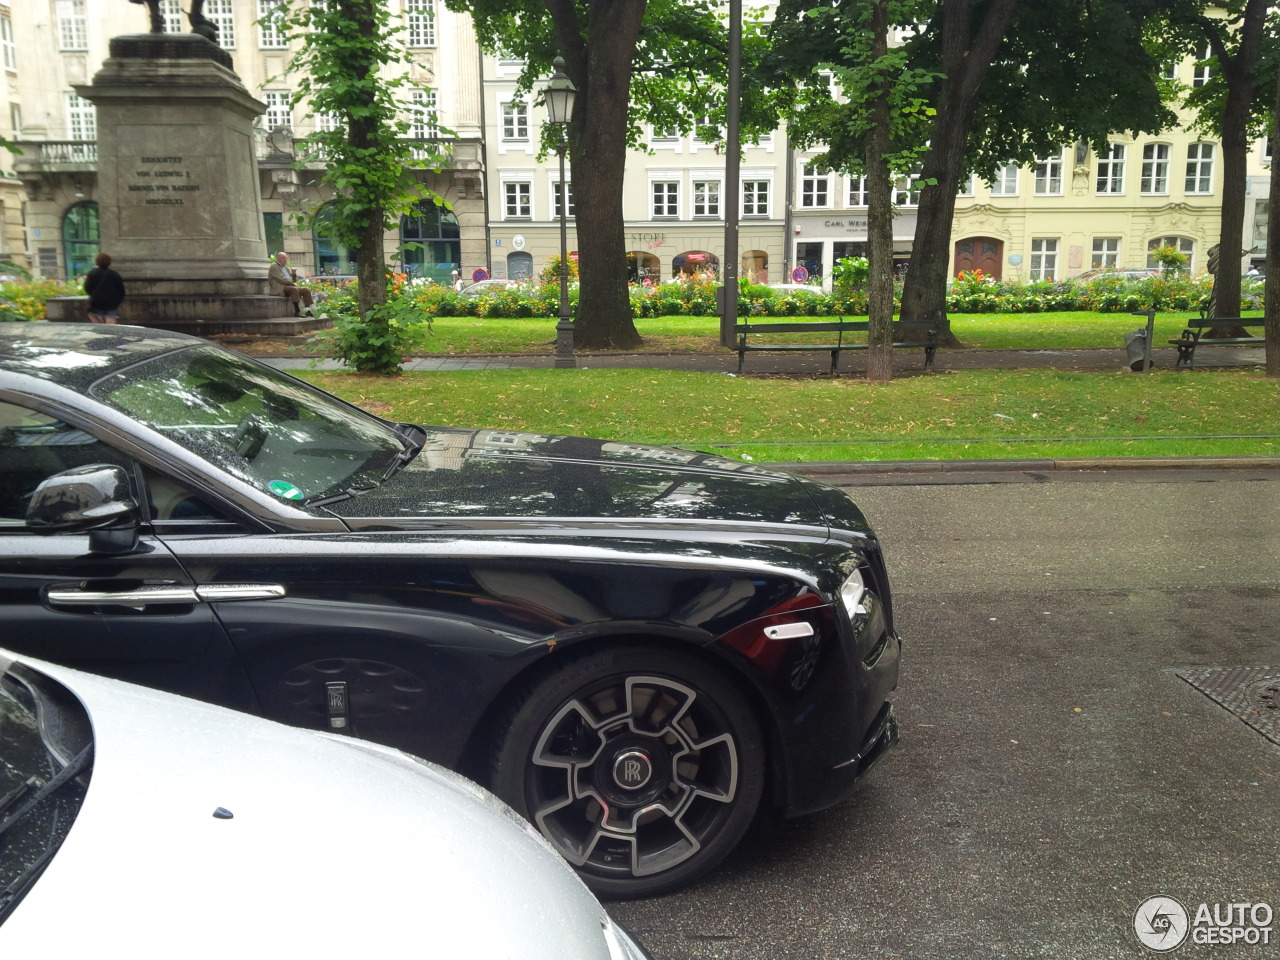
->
[[0, 323, 900, 896]]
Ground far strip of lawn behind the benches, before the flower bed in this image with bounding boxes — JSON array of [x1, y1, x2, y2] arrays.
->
[[407, 311, 1249, 355]]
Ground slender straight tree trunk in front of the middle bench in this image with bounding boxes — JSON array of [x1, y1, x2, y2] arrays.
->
[[867, 0, 893, 383]]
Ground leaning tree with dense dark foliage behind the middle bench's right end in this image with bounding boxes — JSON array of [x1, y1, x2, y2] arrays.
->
[[773, 0, 1174, 343]]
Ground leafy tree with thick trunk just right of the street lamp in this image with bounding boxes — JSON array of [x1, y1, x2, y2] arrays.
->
[[445, 0, 758, 348]]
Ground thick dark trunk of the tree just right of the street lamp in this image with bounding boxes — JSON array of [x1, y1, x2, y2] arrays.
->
[[547, 0, 645, 349]]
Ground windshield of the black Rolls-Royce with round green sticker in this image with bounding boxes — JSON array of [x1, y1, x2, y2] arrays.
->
[[90, 346, 408, 500]]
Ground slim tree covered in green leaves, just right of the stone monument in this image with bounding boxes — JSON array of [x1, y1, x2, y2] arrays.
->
[[273, 0, 445, 374]]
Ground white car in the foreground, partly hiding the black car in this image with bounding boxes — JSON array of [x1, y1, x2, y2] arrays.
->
[[0, 652, 646, 960]]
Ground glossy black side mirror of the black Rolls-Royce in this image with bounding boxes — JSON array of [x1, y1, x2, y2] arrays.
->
[[27, 463, 142, 553]]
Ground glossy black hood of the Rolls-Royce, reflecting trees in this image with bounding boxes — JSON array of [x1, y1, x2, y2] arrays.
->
[[326, 428, 827, 535]]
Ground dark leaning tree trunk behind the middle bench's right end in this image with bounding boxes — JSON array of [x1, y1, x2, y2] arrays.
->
[[901, 0, 1019, 347]]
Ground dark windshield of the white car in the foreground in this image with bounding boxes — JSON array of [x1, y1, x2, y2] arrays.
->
[[0, 664, 92, 923]]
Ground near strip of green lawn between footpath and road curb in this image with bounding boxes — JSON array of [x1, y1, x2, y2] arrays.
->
[[300, 366, 1280, 462]]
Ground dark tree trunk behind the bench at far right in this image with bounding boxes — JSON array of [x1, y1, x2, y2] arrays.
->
[[1204, 0, 1267, 339]]
